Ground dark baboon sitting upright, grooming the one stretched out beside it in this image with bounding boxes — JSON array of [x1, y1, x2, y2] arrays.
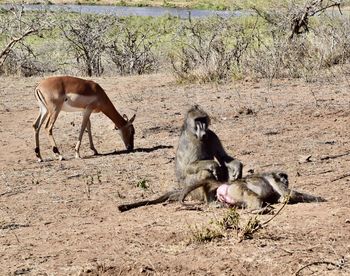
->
[[118, 105, 243, 212]]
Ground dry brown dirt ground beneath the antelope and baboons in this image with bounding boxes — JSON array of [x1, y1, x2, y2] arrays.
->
[[0, 74, 350, 275]]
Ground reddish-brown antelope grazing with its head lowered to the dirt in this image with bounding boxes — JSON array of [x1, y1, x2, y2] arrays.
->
[[33, 76, 136, 162]]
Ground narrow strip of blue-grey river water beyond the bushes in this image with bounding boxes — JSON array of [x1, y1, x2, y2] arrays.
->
[[0, 4, 244, 18]]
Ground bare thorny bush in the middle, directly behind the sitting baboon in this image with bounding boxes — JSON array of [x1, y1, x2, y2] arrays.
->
[[169, 17, 253, 82]]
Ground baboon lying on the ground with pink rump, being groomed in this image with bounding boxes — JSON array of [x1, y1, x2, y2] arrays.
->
[[180, 170, 325, 211]]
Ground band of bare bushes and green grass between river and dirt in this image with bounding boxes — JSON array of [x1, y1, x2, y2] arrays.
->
[[0, 0, 350, 82]]
